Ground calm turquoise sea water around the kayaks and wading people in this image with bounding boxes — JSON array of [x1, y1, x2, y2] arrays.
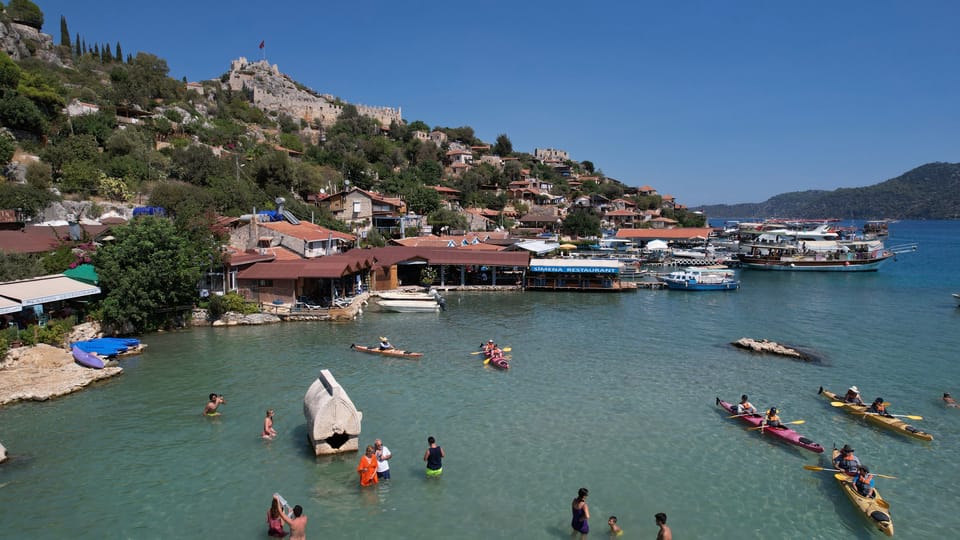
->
[[0, 222, 960, 539]]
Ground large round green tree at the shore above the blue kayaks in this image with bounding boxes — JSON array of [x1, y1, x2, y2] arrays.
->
[[93, 216, 217, 332]]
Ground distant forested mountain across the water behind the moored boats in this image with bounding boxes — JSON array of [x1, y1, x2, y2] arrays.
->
[[695, 162, 960, 219]]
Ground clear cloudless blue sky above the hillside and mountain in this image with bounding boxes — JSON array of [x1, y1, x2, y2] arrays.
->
[[35, 0, 960, 206]]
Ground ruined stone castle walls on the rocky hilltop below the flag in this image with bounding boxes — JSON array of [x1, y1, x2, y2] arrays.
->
[[226, 57, 403, 128]]
